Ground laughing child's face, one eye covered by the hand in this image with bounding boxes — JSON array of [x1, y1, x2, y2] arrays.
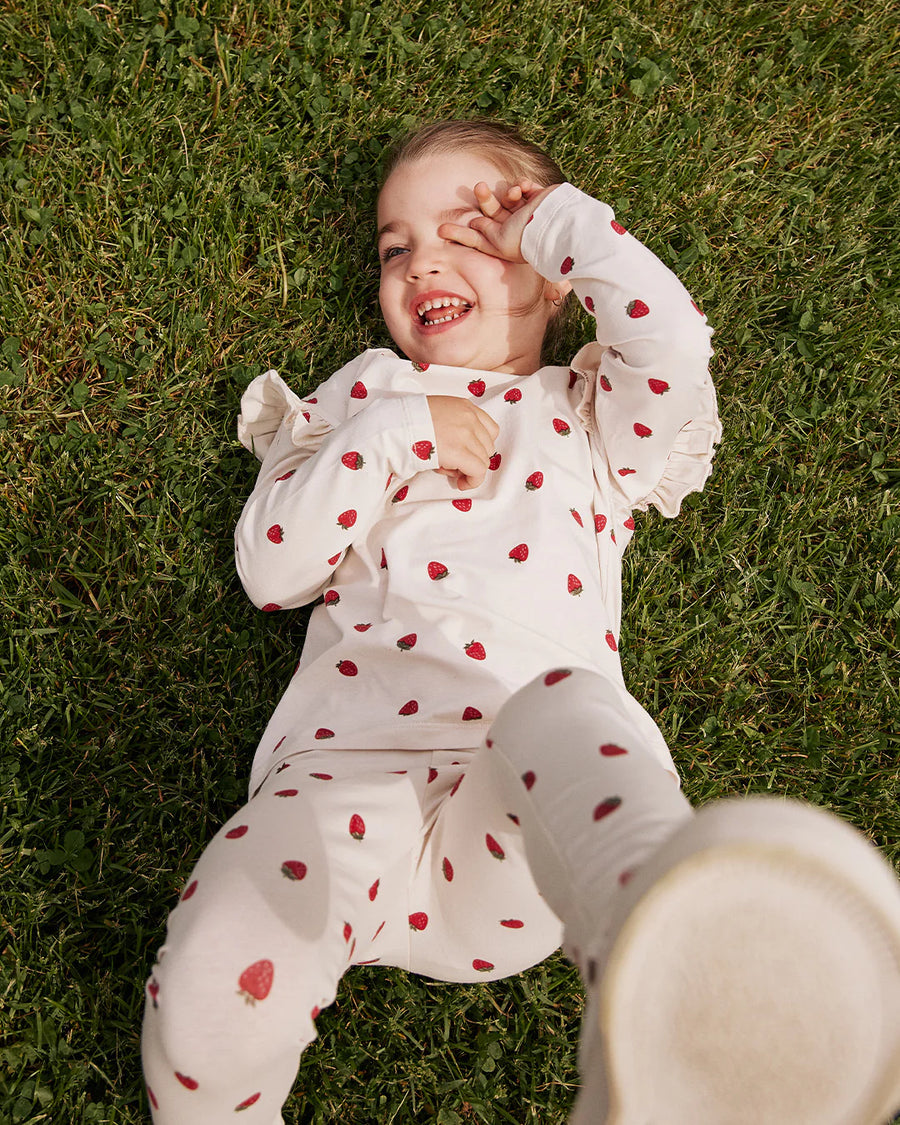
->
[[378, 151, 554, 375]]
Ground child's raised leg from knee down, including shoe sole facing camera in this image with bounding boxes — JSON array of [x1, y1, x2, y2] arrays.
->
[[488, 669, 900, 1125]]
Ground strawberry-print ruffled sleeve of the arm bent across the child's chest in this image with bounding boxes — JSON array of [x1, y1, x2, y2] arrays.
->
[[235, 357, 438, 610]]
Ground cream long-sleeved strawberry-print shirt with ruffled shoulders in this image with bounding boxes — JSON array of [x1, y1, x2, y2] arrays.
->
[[235, 185, 721, 790]]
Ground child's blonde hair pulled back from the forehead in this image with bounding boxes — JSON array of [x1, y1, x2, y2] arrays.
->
[[380, 117, 577, 362]]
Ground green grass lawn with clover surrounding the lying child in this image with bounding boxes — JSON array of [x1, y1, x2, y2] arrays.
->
[[0, 0, 900, 1125]]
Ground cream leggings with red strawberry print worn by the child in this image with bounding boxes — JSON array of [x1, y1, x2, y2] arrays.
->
[[143, 668, 692, 1125]]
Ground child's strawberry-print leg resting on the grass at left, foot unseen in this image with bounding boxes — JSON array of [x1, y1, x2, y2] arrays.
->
[[143, 752, 429, 1125]]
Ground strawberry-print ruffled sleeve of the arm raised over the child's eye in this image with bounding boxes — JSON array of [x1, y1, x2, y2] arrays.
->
[[522, 183, 721, 518]]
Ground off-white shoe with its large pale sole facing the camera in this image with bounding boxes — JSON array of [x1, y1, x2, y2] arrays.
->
[[570, 798, 900, 1125]]
